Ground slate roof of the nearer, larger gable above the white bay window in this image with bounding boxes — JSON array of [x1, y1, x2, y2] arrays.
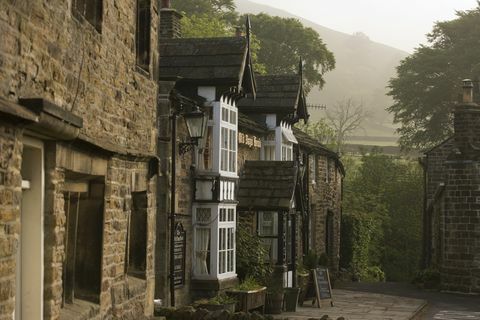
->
[[160, 37, 255, 93]]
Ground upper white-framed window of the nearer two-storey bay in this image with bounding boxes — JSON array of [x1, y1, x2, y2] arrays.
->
[[213, 97, 238, 178]]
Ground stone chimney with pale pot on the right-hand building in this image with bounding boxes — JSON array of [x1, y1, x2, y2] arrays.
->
[[453, 79, 480, 159]]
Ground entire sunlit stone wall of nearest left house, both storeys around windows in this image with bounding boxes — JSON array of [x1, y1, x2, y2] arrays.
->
[[0, 0, 159, 319]]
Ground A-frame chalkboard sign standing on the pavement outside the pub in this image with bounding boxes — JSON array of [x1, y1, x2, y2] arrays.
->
[[302, 267, 333, 308]]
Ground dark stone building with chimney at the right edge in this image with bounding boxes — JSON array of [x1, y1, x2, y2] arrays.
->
[[422, 80, 480, 293]]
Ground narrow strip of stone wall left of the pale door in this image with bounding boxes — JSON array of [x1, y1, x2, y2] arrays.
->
[[0, 118, 23, 319]]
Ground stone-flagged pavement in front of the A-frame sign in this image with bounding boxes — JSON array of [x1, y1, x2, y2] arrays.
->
[[275, 289, 426, 320]]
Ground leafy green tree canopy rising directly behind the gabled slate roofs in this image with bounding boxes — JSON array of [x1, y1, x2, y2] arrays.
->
[[172, 0, 335, 92]]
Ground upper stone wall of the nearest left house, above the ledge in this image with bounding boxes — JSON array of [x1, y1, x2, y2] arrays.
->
[[0, 0, 158, 152]]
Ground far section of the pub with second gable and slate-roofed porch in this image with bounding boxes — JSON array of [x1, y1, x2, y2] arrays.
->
[[238, 74, 345, 287]]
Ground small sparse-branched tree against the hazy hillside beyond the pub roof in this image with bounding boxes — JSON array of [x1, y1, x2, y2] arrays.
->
[[326, 98, 368, 152]]
